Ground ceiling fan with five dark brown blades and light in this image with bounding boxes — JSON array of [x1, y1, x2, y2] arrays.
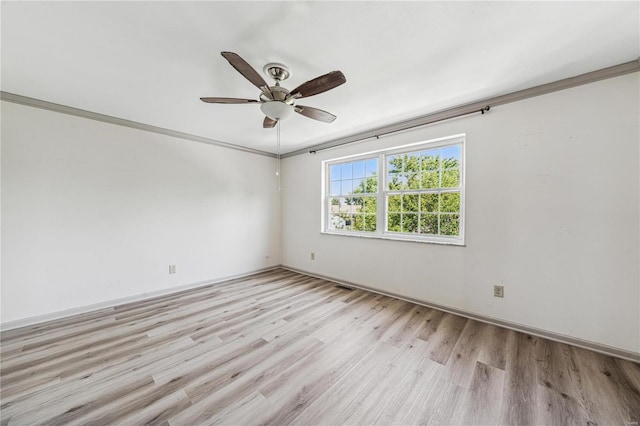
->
[[200, 52, 347, 129]]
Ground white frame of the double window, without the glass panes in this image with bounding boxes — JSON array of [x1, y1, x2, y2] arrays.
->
[[321, 134, 466, 246]]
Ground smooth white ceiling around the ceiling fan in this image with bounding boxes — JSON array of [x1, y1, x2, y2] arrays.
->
[[1, 1, 640, 152]]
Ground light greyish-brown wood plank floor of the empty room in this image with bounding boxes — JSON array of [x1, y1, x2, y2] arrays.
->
[[0, 269, 640, 425]]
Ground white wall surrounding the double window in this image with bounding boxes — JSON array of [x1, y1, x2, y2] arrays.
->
[[282, 73, 640, 353]]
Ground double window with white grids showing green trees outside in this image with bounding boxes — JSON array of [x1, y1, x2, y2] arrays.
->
[[323, 136, 464, 244]]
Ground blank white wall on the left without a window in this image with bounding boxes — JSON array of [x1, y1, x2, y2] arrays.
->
[[1, 102, 281, 323]]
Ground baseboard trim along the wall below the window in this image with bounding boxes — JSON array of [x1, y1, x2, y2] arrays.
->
[[280, 265, 640, 363]]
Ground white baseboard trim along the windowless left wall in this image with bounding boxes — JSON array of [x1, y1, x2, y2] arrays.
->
[[0, 265, 281, 332]]
